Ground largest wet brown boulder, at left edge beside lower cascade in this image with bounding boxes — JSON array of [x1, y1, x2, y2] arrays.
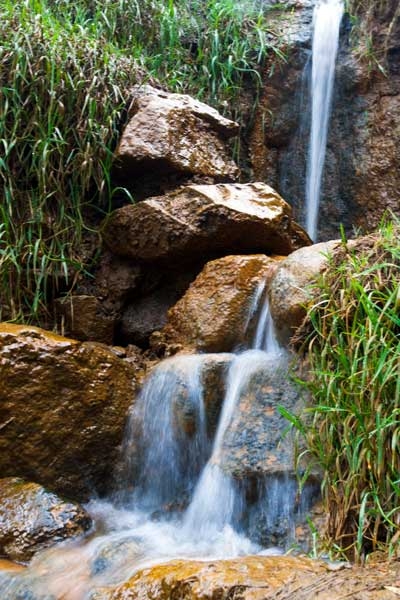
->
[[0, 323, 135, 499]]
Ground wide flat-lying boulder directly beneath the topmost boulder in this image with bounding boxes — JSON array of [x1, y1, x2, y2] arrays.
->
[[102, 183, 310, 264]]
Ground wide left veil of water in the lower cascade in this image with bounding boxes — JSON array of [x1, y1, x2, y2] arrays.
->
[[120, 355, 208, 511]]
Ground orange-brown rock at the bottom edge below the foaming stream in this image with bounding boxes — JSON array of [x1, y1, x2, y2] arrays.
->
[[104, 556, 325, 600]]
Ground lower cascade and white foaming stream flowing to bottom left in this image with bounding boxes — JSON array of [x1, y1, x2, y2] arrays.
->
[[0, 287, 316, 600]]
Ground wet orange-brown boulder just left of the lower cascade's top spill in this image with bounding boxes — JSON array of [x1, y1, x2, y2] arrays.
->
[[162, 254, 276, 352]]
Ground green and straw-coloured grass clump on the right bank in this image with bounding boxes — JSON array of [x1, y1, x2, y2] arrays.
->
[[298, 222, 400, 560]]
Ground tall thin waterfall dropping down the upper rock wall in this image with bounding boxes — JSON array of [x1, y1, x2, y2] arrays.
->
[[306, 0, 344, 241]]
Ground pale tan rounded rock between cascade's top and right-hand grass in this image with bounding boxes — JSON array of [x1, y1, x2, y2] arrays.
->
[[269, 240, 340, 345]]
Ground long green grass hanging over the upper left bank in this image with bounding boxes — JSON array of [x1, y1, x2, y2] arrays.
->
[[0, 0, 281, 325]]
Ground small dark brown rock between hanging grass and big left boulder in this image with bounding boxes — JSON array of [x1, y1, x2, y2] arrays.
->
[[56, 296, 114, 344]]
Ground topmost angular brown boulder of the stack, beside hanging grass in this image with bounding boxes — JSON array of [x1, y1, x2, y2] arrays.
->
[[116, 85, 239, 181]]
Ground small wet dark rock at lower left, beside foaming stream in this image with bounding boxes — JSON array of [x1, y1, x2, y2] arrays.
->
[[0, 478, 91, 562]]
